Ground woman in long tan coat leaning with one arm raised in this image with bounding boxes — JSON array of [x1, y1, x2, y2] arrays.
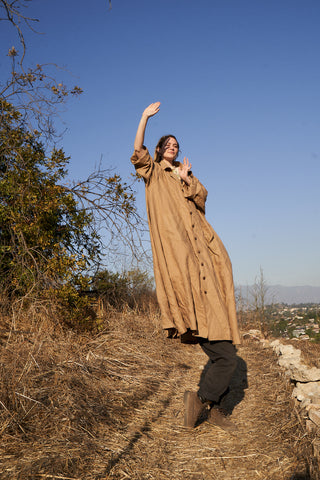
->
[[131, 102, 240, 430]]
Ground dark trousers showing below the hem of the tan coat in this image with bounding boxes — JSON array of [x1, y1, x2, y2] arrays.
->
[[198, 339, 237, 404]]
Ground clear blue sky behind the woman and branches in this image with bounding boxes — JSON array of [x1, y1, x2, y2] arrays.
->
[[0, 0, 320, 286]]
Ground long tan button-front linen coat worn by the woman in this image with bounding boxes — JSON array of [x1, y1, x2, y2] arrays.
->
[[131, 149, 240, 344]]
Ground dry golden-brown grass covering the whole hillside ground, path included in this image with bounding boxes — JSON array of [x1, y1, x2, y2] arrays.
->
[[0, 311, 320, 480]]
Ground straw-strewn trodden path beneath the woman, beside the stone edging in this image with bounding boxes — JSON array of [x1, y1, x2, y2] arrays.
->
[[96, 343, 310, 480]]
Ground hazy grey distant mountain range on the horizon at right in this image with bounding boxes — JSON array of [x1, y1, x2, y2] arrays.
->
[[236, 285, 320, 305]]
